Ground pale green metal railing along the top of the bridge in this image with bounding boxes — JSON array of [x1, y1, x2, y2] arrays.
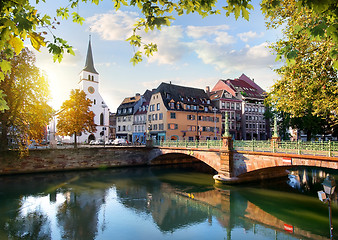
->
[[154, 140, 338, 157]]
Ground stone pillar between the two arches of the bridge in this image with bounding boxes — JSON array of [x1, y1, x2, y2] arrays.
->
[[214, 136, 237, 183]]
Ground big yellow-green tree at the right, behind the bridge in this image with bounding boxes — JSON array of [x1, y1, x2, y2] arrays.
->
[[267, 1, 338, 123]]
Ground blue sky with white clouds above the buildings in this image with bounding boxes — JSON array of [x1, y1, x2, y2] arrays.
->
[[27, 0, 281, 112]]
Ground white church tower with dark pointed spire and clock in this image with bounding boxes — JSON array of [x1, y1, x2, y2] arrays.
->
[[78, 36, 109, 143]]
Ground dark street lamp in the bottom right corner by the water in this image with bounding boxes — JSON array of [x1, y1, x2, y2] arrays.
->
[[318, 175, 336, 239]]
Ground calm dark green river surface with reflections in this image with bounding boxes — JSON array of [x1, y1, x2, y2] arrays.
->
[[0, 166, 338, 240]]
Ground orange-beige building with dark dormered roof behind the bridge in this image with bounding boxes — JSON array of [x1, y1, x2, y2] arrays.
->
[[147, 83, 221, 141]]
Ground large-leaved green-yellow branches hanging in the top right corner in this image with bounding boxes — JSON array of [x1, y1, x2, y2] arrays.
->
[[261, 0, 338, 70]]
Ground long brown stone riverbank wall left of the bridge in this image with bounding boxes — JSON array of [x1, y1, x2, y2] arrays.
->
[[0, 146, 197, 175]]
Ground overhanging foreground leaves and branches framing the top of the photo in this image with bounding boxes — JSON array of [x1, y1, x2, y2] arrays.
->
[[0, 0, 338, 121]]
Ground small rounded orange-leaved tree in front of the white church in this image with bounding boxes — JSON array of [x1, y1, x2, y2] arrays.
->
[[56, 89, 96, 148]]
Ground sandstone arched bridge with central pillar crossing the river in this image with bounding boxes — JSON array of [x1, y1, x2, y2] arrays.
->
[[149, 138, 338, 183]]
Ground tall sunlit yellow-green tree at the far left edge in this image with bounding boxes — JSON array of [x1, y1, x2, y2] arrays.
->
[[0, 48, 53, 150]]
